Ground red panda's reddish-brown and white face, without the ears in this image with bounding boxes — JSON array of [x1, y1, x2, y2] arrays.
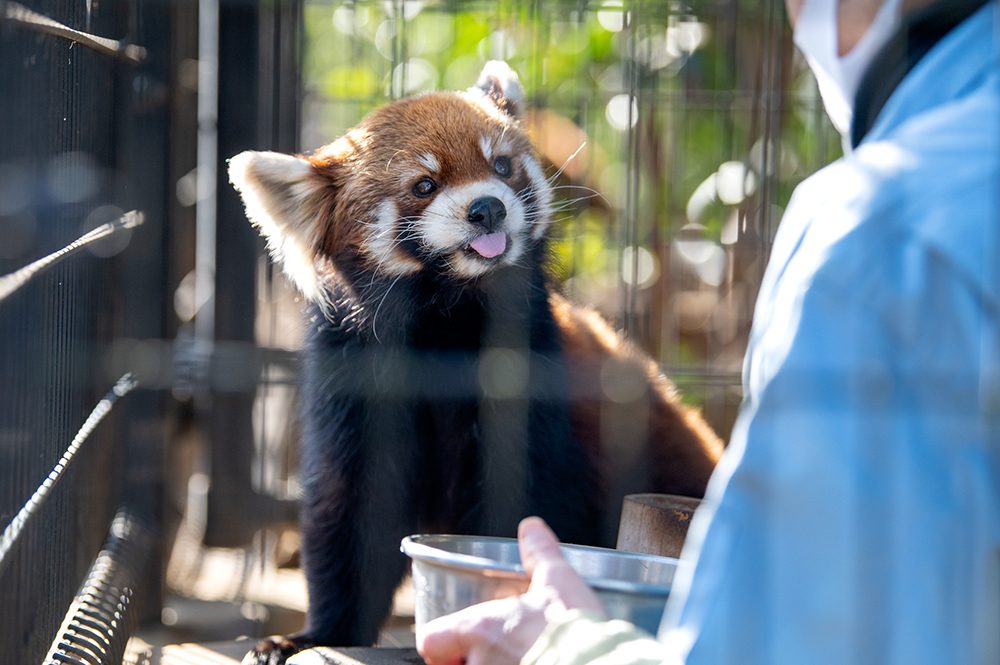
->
[[326, 93, 550, 279]]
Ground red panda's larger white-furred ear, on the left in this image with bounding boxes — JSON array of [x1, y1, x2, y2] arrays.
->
[[229, 150, 329, 300]]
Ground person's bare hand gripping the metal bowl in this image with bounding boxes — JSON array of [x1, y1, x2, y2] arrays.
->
[[417, 517, 604, 665]]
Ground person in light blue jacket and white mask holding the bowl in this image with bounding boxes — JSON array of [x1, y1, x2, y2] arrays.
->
[[418, 0, 1000, 665]]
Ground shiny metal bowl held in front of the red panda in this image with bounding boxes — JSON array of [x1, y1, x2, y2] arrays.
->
[[401, 535, 680, 635]]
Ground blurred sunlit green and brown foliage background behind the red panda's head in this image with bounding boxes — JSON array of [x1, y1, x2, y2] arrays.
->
[[303, 0, 840, 412]]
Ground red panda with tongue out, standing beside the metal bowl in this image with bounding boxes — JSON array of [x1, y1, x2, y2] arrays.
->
[[229, 62, 721, 664]]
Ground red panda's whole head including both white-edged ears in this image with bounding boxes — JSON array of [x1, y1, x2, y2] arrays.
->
[[230, 63, 552, 297]]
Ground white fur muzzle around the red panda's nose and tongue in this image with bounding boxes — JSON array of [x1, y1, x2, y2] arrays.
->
[[417, 178, 528, 278]]
